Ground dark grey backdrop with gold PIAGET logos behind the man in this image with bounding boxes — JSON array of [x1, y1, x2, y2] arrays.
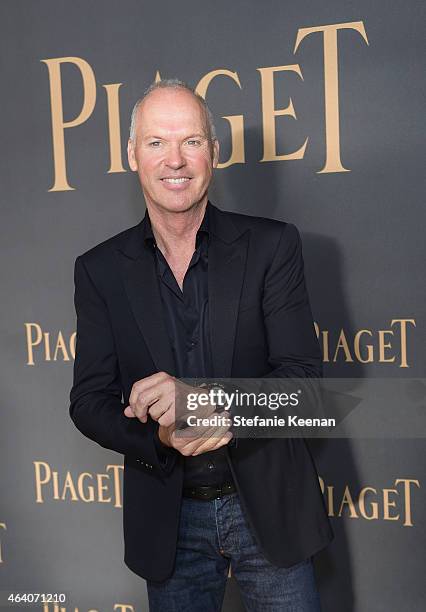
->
[[0, 0, 426, 612]]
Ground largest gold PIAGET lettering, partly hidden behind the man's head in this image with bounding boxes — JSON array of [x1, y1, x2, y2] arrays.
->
[[40, 21, 368, 191]]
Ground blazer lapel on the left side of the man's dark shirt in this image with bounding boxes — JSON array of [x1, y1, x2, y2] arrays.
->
[[117, 221, 175, 375]]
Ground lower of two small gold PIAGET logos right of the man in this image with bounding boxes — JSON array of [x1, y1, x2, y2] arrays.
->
[[319, 477, 420, 527]]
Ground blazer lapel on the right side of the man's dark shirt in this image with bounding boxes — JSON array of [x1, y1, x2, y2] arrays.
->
[[208, 204, 249, 378]]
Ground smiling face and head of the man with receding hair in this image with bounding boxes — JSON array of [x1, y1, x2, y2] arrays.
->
[[128, 88, 218, 212]]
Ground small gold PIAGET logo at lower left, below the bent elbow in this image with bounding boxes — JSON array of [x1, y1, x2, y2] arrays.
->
[[33, 461, 123, 508]]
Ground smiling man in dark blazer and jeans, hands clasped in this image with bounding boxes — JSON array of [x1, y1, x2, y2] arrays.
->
[[70, 80, 332, 612]]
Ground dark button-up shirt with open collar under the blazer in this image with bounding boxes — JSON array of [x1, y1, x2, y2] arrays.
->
[[145, 204, 233, 487]]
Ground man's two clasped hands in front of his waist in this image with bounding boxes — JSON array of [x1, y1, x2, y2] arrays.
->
[[124, 372, 232, 456]]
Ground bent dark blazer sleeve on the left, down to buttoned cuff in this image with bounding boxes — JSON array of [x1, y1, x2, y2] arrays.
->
[[69, 257, 173, 472]]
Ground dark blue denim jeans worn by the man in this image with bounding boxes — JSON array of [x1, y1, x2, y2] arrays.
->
[[147, 493, 320, 612]]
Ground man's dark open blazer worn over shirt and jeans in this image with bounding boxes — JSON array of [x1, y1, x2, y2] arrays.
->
[[70, 203, 332, 581]]
